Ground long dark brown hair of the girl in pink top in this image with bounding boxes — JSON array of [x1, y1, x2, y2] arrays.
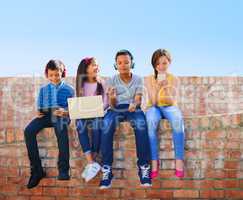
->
[[76, 57, 104, 97]]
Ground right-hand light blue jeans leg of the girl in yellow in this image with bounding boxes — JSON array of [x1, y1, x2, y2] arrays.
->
[[160, 106, 185, 160]]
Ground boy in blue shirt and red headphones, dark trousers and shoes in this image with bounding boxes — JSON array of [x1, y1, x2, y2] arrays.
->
[[24, 60, 74, 189]]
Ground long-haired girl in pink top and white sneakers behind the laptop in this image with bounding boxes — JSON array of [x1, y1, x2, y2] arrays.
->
[[76, 57, 108, 182]]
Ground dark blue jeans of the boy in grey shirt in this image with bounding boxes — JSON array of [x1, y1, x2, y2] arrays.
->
[[101, 104, 150, 166]]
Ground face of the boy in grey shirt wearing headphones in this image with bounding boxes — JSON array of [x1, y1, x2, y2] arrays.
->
[[116, 55, 132, 74]]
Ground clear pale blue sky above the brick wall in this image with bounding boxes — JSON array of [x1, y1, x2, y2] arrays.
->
[[0, 0, 243, 76]]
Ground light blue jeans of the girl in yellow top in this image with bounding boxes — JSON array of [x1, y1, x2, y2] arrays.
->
[[146, 106, 185, 160]]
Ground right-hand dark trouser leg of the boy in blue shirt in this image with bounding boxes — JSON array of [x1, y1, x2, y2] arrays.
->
[[53, 117, 70, 173]]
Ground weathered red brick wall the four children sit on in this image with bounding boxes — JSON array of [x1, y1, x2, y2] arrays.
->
[[0, 77, 243, 200]]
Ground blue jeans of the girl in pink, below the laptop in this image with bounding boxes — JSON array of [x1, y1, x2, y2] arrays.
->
[[76, 118, 103, 154]]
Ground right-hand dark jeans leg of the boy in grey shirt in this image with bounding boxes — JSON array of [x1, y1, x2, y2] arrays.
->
[[126, 109, 151, 166]]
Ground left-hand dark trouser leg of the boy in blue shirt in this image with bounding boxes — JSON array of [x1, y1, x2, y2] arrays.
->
[[24, 116, 51, 173]]
